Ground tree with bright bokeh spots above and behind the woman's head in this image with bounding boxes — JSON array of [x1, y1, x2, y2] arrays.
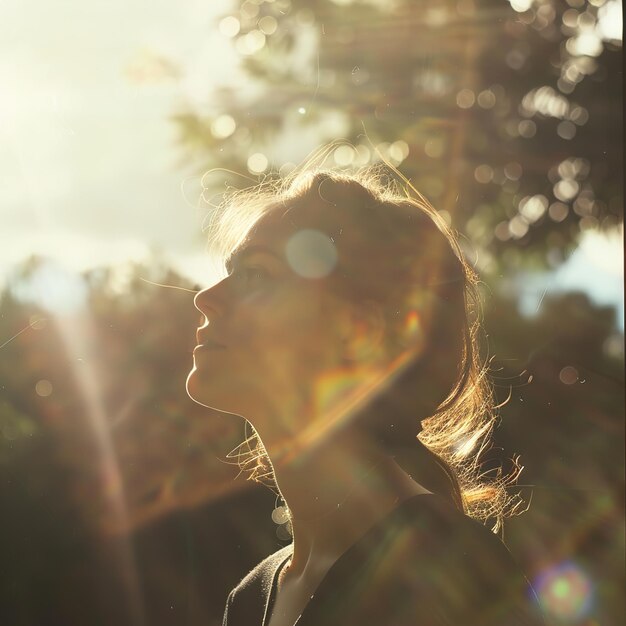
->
[[173, 0, 623, 275]]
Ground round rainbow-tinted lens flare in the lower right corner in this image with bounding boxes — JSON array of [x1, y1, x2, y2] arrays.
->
[[535, 561, 593, 624]]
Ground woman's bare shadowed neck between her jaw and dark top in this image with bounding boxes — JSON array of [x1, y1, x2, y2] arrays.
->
[[268, 429, 426, 576]]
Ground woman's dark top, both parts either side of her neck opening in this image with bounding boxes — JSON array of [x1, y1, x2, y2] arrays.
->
[[223, 494, 544, 626]]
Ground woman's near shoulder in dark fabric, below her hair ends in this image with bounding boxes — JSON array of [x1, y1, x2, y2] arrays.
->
[[330, 496, 543, 626]]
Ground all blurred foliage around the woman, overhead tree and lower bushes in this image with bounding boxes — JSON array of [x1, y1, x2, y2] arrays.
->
[[0, 0, 624, 626]]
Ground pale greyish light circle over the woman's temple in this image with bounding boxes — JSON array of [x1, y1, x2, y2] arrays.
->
[[286, 229, 337, 278]]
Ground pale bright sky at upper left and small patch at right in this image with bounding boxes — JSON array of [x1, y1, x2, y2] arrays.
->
[[0, 0, 623, 329]]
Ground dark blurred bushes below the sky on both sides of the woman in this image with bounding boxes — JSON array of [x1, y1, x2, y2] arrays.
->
[[0, 259, 624, 626]]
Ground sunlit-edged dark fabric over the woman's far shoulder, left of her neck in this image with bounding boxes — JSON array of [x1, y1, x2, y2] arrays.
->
[[223, 545, 292, 626]]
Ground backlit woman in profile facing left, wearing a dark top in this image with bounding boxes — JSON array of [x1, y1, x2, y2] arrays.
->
[[187, 165, 542, 626]]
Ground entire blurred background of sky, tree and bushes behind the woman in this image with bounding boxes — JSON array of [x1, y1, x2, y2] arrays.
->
[[0, 0, 626, 626]]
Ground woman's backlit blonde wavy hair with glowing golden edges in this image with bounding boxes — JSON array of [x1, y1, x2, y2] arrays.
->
[[204, 154, 521, 532]]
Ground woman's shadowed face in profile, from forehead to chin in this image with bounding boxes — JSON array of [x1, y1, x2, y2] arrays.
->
[[187, 211, 354, 437]]
